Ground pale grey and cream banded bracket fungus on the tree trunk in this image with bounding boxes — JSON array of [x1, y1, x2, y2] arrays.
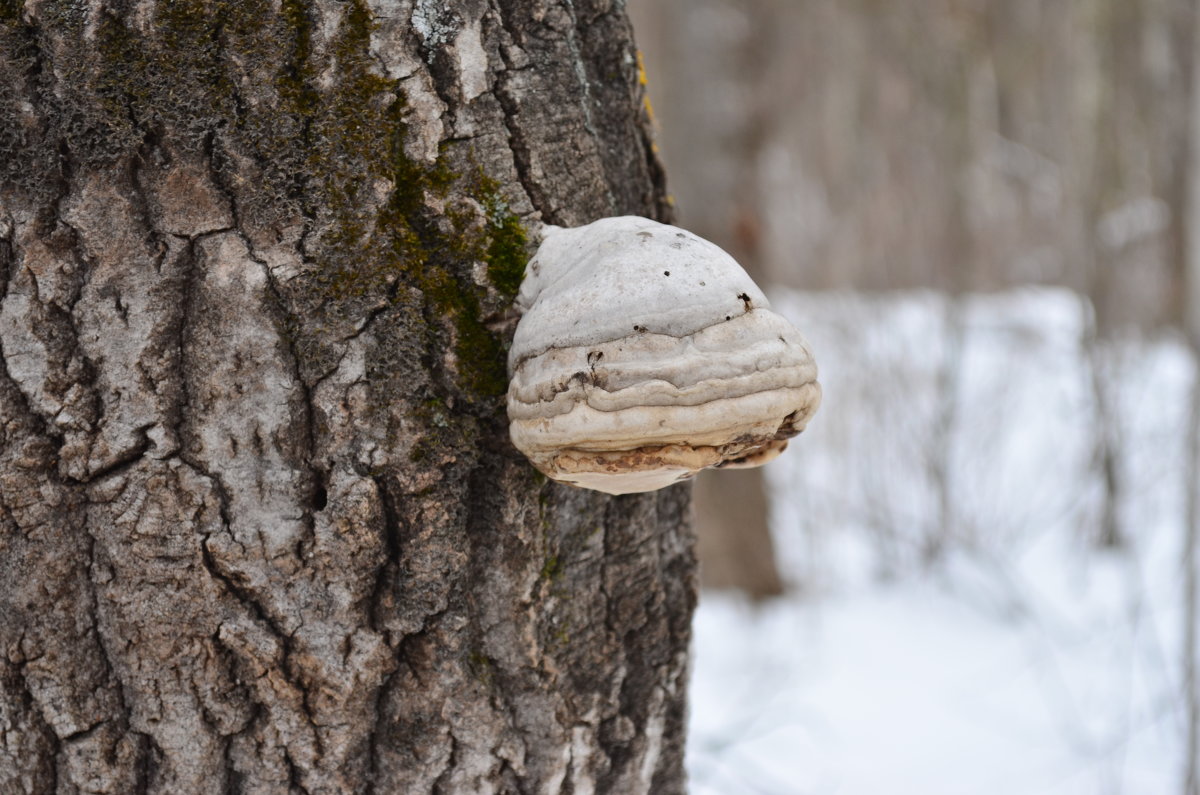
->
[[508, 216, 821, 494]]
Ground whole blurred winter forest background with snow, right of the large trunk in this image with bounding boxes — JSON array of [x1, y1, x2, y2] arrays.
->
[[630, 0, 1200, 795]]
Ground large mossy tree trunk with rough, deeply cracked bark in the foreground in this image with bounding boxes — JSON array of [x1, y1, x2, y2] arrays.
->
[[0, 0, 695, 795]]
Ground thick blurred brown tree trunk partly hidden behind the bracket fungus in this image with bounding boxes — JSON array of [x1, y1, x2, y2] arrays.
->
[[630, 0, 784, 599]]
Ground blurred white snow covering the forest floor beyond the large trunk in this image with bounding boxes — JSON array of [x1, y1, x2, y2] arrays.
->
[[689, 289, 1193, 795]]
